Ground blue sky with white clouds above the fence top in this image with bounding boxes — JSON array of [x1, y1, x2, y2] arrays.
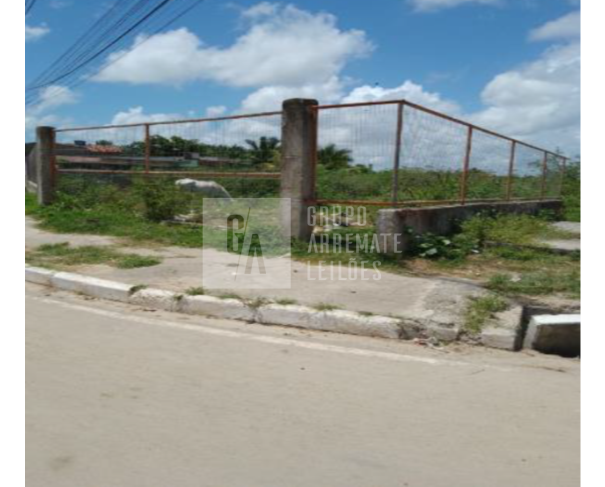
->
[[25, 0, 581, 156]]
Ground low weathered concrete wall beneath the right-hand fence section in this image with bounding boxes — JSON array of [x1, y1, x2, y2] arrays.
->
[[377, 200, 563, 254]]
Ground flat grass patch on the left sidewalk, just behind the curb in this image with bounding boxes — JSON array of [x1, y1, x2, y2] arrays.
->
[[25, 243, 162, 269]]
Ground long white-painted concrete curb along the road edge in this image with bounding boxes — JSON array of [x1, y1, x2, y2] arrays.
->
[[25, 266, 522, 350]]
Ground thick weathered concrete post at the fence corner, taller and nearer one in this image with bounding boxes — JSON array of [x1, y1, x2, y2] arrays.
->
[[281, 98, 318, 241]]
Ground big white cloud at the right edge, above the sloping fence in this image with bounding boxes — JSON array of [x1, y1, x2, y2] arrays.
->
[[472, 42, 581, 154]]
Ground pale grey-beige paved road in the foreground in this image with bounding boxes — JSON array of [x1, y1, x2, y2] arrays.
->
[[26, 286, 580, 487]]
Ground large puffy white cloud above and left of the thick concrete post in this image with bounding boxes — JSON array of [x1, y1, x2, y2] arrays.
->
[[96, 3, 372, 87]]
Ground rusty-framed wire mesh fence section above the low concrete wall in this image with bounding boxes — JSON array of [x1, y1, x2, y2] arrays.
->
[[315, 100, 568, 207]]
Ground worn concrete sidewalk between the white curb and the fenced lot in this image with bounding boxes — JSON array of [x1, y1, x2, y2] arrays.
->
[[25, 220, 520, 341]]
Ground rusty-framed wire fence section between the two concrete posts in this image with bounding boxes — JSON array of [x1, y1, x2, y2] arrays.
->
[[54, 112, 281, 196]]
